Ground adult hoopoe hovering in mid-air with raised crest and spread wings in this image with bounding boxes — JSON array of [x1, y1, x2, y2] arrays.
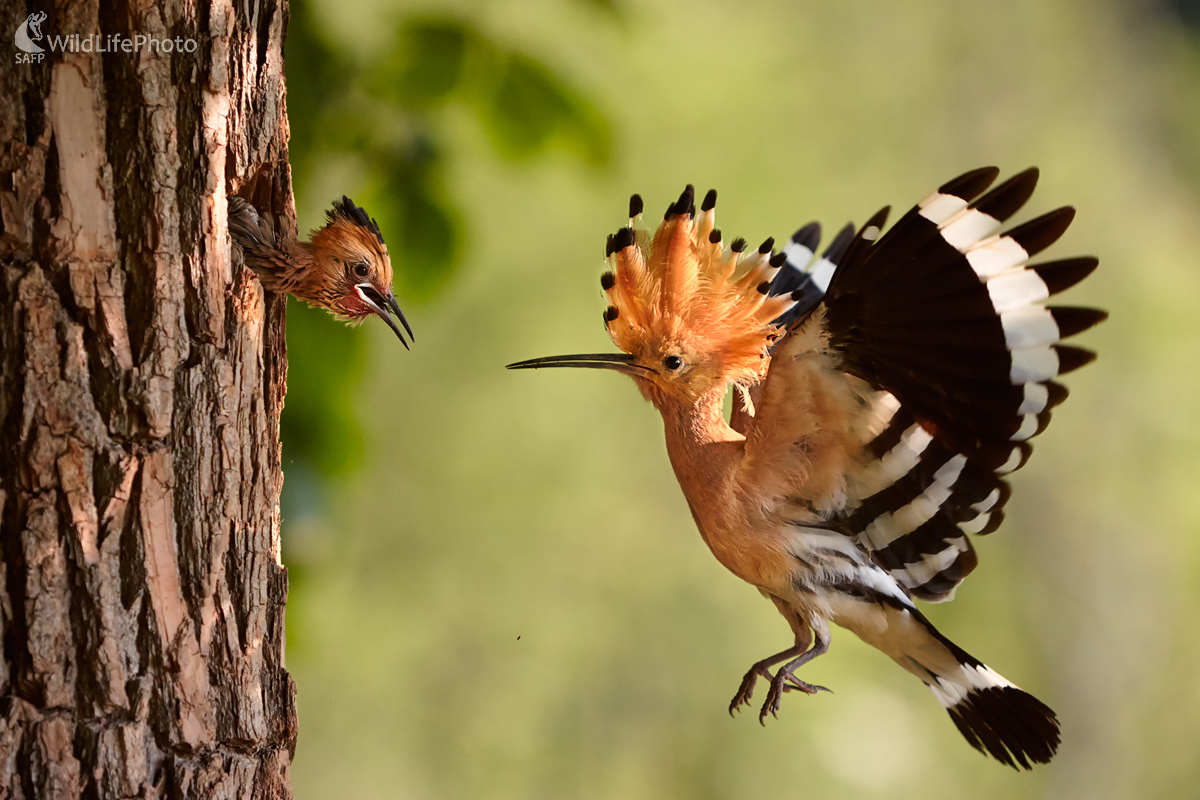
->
[[509, 168, 1106, 769]]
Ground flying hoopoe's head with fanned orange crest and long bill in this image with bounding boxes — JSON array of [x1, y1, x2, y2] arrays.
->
[[510, 185, 796, 408]]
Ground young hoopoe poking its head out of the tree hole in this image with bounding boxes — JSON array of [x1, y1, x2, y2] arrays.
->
[[229, 196, 415, 349]]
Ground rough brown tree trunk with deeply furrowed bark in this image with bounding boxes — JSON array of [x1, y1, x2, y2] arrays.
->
[[0, 0, 296, 800]]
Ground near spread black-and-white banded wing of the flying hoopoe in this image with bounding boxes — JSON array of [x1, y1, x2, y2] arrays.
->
[[742, 168, 1106, 601]]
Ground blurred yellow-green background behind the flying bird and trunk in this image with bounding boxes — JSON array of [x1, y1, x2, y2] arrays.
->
[[274, 0, 1200, 800]]
